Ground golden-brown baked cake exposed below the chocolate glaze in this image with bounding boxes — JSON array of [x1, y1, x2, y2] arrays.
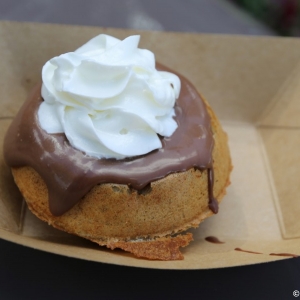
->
[[12, 99, 232, 260]]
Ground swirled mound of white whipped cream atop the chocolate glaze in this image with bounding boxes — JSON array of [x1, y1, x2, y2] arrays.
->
[[38, 34, 180, 159]]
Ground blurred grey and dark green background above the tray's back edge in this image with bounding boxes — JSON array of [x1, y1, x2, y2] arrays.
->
[[0, 0, 300, 36]]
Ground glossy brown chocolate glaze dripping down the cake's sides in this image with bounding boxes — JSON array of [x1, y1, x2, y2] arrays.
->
[[4, 66, 218, 216]]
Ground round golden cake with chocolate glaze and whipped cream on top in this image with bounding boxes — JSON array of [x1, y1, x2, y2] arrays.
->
[[4, 35, 231, 260]]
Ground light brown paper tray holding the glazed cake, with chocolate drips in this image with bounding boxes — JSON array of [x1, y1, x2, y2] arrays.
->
[[0, 22, 300, 269]]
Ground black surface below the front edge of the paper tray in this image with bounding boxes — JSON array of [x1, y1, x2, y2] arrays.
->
[[0, 240, 300, 300]]
